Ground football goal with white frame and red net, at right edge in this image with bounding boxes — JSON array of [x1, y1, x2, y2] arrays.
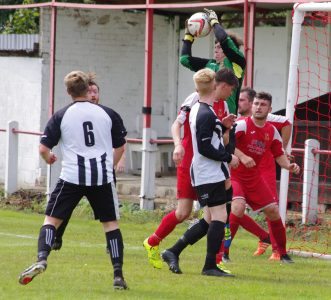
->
[[280, 2, 331, 258]]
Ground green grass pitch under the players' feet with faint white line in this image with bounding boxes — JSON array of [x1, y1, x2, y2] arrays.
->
[[0, 209, 331, 300]]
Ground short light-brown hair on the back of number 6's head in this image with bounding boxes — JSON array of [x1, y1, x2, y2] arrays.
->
[[64, 71, 89, 97]]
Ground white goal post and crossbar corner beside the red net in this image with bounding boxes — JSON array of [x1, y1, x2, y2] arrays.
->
[[279, 2, 331, 223]]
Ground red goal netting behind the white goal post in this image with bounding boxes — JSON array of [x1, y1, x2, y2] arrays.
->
[[287, 12, 331, 254]]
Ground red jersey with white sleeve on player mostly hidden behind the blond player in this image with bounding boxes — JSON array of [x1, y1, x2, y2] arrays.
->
[[177, 92, 229, 169]]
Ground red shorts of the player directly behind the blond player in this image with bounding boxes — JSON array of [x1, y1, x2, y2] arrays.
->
[[177, 167, 198, 200]]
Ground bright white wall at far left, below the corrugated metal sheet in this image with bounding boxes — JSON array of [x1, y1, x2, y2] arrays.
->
[[0, 57, 42, 187]]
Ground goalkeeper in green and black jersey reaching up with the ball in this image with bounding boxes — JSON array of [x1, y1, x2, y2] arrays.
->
[[180, 8, 246, 114]]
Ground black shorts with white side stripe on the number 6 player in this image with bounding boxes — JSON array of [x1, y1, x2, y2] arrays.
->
[[45, 179, 119, 222]]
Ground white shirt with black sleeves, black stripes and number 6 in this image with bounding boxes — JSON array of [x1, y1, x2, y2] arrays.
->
[[40, 101, 127, 186]]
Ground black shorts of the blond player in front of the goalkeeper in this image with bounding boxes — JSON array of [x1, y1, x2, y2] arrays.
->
[[195, 181, 227, 207]]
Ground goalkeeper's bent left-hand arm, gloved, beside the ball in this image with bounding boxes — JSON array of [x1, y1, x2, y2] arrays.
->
[[179, 20, 214, 72]]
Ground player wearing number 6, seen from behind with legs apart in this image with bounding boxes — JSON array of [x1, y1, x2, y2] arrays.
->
[[19, 71, 127, 289]]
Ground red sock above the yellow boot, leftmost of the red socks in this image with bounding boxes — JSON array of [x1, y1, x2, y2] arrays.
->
[[148, 210, 181, 246]]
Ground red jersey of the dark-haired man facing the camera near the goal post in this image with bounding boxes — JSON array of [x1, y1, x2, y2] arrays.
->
[[231, 117, 284, 181]]
